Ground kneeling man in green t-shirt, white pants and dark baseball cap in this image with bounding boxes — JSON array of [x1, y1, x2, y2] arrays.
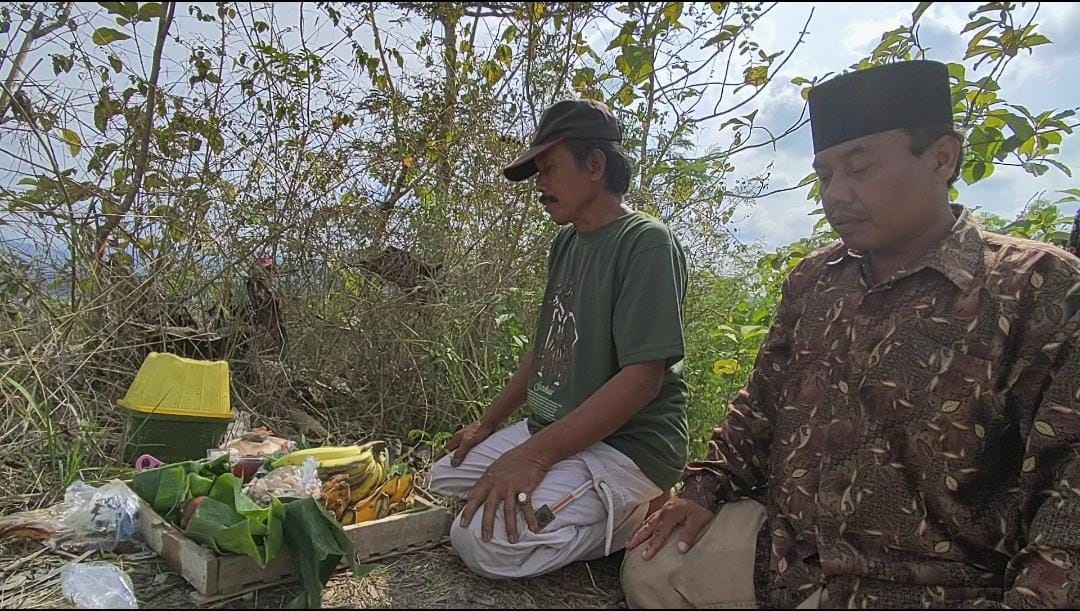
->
[[431, 100, 687, 578]]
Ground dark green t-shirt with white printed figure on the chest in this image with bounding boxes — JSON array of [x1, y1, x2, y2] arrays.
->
[[528, 213, 688, 490]]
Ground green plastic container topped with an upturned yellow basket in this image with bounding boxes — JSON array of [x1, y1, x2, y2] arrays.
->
[[117, 352, 233, 464]]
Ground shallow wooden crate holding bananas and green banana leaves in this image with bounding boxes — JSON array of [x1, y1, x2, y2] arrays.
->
[[137, 499, 454, 598]]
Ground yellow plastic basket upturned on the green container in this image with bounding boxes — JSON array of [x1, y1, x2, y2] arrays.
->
[[117, 352, 232, 420]]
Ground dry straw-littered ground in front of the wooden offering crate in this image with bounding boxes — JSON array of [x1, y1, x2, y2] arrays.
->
[[0, 544, 623, 609]]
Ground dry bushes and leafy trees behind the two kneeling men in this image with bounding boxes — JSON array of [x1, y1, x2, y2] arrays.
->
[[0, 2, 1076, 500]]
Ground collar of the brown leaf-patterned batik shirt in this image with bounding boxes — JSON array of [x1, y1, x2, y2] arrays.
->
[[825, 204, 986, 291]]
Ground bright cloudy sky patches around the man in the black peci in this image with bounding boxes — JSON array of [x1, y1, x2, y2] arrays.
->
[[735, 2, 1080, 248]]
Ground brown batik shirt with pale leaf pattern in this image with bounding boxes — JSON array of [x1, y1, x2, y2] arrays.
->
[[680, 206, 1080, 608]]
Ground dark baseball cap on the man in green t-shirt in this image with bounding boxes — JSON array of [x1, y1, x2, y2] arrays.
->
[[502, 99, 622, 182]]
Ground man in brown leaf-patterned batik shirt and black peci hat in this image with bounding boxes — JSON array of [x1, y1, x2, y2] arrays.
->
[[623, 62, 1080, 608]]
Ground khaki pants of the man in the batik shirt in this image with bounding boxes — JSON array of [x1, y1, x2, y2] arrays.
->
[[622, 501, 821, 609]]
